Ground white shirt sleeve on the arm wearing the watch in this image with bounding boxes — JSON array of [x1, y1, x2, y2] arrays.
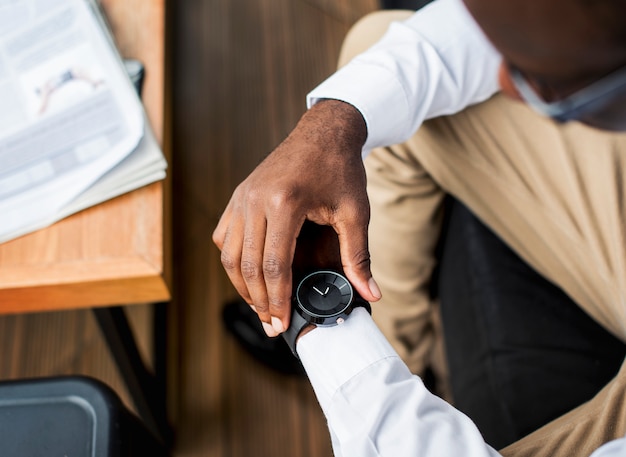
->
[[297, 308, 626, 457]]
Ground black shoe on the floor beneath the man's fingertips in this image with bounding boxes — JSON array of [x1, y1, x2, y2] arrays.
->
[[222, 300, 305, 376]]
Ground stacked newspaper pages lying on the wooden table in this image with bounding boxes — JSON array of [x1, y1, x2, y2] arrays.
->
[[0, 0, 154, 241]]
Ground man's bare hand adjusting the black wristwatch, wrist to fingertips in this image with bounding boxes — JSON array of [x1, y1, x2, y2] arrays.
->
[[213, 100, 380, 336]]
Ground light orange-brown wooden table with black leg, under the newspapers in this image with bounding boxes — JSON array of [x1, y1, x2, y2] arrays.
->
[[0, 0, 170, 444]]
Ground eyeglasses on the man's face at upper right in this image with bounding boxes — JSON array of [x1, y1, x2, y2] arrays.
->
[[508, 64, 626, 125]]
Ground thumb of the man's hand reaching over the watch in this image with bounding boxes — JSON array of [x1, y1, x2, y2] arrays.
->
[[336, 224, 382, 302]]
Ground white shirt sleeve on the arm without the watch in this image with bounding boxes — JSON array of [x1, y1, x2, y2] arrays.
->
[[307, 0, 501, 154]]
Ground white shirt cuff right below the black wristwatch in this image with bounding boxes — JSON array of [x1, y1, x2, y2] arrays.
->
[[296, 307, 399, 413]]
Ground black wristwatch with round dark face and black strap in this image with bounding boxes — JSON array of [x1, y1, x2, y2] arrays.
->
[[283, 270, 371, 357]]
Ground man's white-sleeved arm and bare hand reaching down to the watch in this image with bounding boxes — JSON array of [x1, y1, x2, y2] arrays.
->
[[213, 0, 496, 336]]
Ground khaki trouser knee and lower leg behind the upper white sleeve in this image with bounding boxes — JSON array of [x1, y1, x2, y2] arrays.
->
[[339, 10, 447, 382]]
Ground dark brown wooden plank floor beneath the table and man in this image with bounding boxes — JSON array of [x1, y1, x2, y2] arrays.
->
[[0, 0, 378, 457]]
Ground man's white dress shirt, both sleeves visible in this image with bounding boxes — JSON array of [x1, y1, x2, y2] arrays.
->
[[297, 0, 626, 457]]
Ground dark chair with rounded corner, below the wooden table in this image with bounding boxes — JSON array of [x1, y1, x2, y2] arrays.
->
[[0, 376, 168, 457]]
